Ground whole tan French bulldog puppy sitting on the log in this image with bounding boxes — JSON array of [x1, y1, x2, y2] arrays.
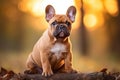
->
[[27, 5, 76, 76]]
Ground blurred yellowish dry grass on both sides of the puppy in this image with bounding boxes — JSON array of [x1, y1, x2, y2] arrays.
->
[[0, 52, 120, 73]]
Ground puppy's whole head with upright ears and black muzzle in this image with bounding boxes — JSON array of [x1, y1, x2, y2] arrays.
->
[[45, 5, 76, 39]]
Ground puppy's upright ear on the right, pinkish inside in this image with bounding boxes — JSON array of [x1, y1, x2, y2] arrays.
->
[[66, 6, 76, 22]]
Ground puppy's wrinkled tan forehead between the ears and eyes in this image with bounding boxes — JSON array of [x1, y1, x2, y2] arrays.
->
[[49, 15, 71, 23]]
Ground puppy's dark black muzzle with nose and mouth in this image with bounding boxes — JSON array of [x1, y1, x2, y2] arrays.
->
[[53, 25, 70, 38]]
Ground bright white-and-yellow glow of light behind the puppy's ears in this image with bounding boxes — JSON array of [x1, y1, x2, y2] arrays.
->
[[19, 0, 74, 17]]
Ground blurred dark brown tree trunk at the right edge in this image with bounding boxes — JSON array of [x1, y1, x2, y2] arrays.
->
[[106, 0, 120, 57]]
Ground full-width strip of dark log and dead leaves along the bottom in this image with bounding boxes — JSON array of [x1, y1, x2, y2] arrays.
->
[[0, 68, 120, 80]]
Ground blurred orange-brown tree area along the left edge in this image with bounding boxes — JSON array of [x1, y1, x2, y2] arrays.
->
[[0, 0, 24, 51]]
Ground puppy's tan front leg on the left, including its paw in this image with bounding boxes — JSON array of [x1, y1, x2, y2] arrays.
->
[[40, 53, 53, 77]]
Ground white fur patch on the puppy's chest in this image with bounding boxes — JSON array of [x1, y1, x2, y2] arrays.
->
[[51, 43, 67, 59]]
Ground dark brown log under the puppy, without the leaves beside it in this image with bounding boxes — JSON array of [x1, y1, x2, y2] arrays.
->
[[21, 72, 116, 80]]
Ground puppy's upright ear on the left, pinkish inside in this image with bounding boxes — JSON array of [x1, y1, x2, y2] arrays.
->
[[45, 5, 55, 22]]
